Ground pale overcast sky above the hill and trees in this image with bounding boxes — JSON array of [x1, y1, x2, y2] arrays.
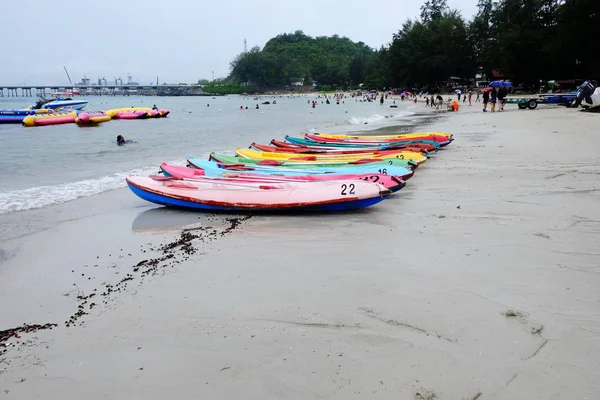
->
[[0, 0, 476, 85]]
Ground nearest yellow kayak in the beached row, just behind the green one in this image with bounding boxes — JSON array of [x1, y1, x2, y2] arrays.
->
[[235, 148, 427, 164]]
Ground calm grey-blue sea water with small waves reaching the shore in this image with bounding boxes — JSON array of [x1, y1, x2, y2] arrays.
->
[[0, 96, 424, 214]]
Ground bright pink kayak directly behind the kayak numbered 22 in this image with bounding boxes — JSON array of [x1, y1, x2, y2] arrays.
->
[[160, 163, 406, 192]]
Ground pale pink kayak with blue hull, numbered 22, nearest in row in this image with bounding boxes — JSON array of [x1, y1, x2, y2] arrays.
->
[[127, 176, 391, 211]]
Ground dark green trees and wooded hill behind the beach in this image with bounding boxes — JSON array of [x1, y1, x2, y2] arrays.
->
[[228, 0, 600, 89]]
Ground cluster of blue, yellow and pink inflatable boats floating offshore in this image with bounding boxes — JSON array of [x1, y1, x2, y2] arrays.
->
[[0, 107, 169, 126]]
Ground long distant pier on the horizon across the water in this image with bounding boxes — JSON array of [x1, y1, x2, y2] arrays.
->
[[0, 85, 206, 98]]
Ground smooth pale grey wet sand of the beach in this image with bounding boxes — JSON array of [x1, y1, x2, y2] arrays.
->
[[0, 107, 600, 400]]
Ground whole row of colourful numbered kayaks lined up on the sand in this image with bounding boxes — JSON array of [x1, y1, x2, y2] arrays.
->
[[127, 132, 453, 212]]
